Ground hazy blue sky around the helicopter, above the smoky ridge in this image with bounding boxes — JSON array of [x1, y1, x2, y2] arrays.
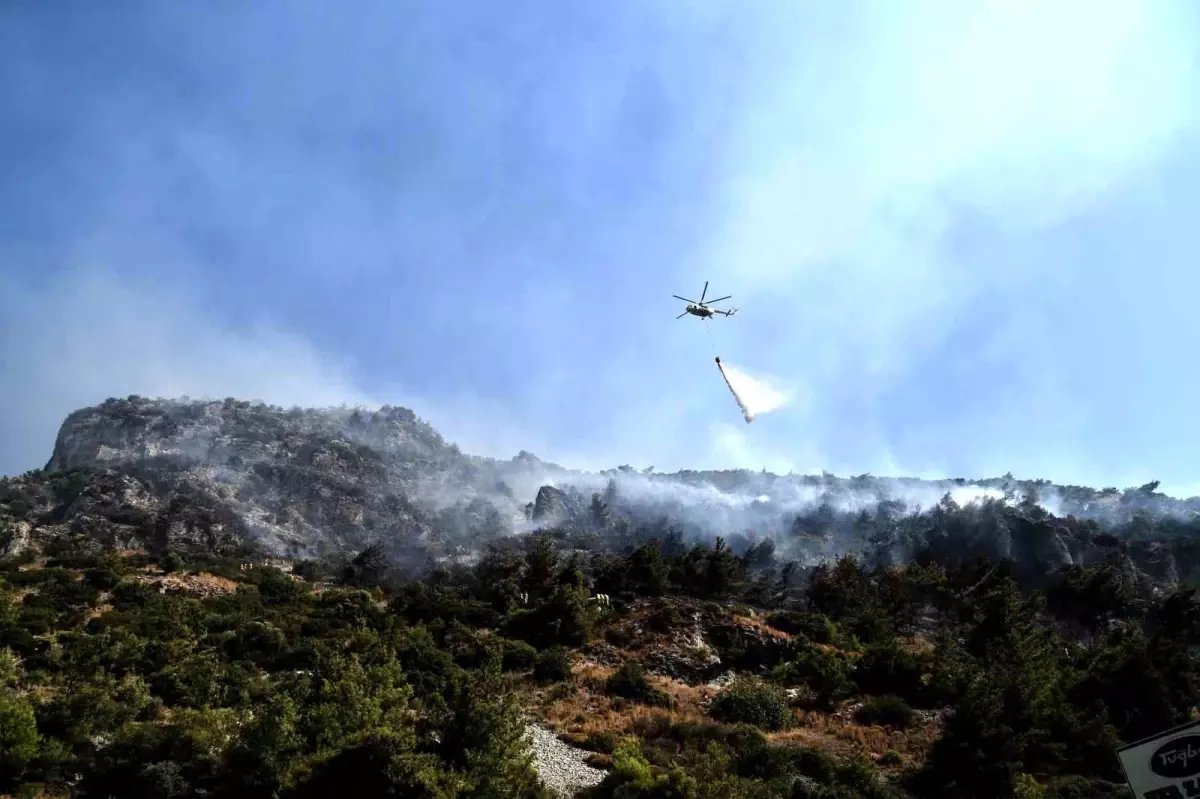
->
[[0, 0, 1200, 494]]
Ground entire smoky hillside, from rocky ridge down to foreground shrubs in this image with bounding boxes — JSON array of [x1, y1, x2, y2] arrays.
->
[[0, 397, 1200, 799]]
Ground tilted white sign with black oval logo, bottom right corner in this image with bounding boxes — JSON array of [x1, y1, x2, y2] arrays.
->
[[1117, 721, 1200, 799]]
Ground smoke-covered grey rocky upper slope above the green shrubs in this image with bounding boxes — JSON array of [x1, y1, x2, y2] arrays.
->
[[0, 396, 1200, 583]]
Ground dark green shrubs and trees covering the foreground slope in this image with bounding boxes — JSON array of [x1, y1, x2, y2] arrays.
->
[[0, 511, 1200, 799]]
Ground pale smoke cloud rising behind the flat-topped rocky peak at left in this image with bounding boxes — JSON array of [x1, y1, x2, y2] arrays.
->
[[0, 268, 378, 473]]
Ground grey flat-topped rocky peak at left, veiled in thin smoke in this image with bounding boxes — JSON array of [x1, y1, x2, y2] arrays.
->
[[0, 397, 516, 560]]
